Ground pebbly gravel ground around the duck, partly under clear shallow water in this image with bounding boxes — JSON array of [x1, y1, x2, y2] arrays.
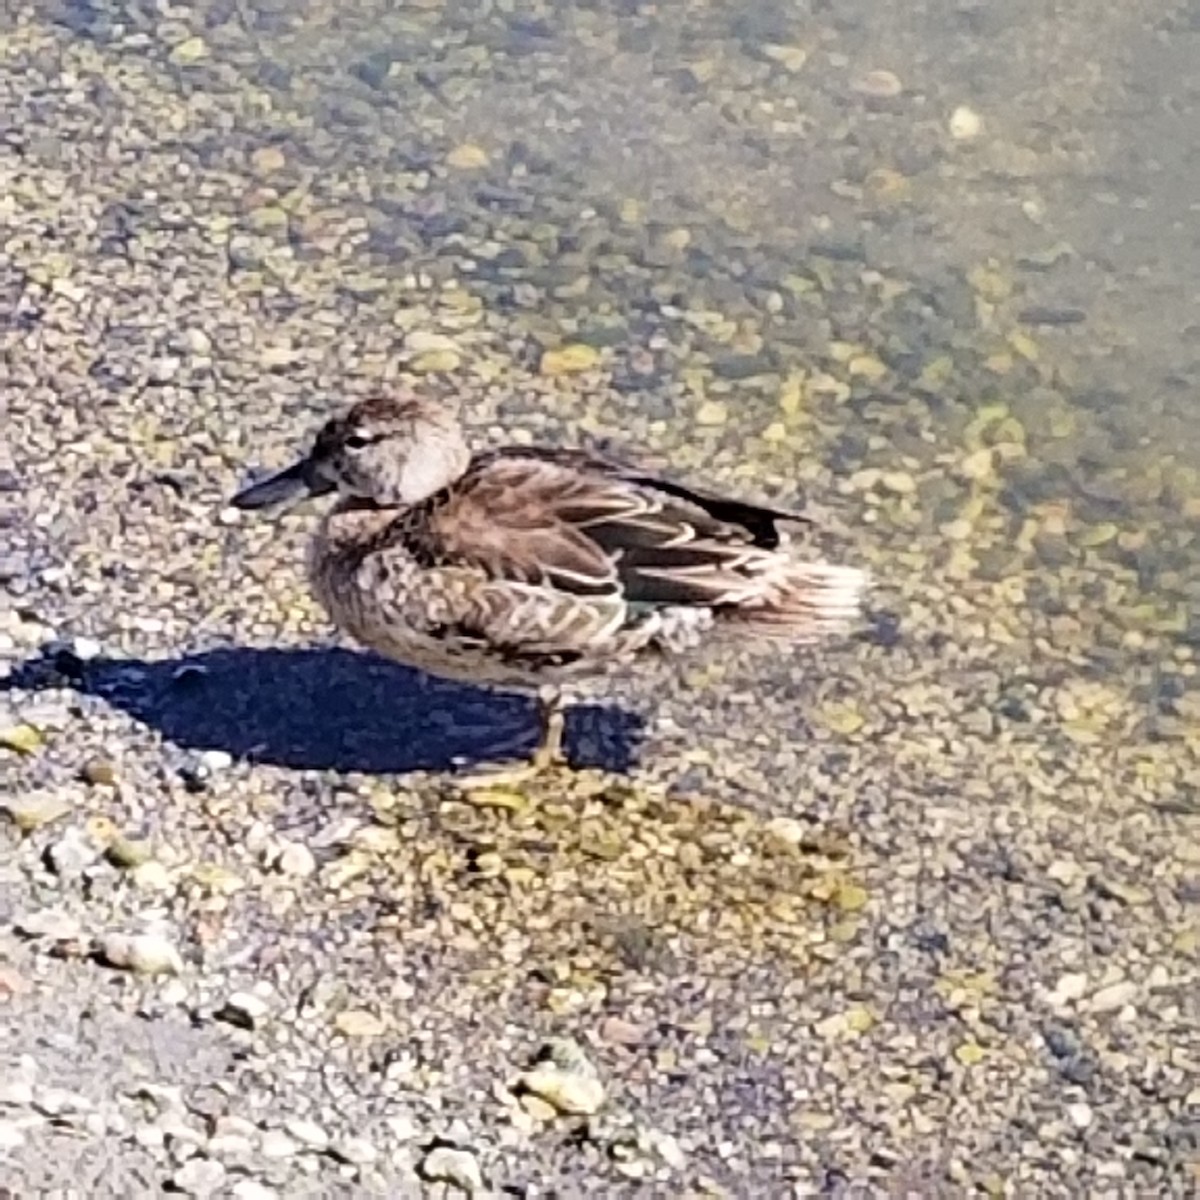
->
[[0, 0, 1200, 1200]]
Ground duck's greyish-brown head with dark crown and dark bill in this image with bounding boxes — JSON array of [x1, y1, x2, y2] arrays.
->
[[229, 392, 470, 509]]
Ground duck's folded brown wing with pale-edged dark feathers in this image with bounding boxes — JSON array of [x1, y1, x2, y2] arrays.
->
[[404, 448, 803, 610]]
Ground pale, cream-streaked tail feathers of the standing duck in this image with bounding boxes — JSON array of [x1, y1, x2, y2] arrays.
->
[[721, 562, 870, 643]]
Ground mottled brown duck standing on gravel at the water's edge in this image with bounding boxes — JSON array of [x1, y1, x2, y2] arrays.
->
[[229, 388, 868, 770]]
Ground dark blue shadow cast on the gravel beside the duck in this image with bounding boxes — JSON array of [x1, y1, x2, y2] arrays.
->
[[7, 647, 643, 774]]
